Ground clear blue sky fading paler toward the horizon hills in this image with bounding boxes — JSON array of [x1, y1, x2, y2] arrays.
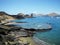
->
[[0, 0, 60, 14]]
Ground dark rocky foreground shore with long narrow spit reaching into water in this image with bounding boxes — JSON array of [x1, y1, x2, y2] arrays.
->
[[0, 22, 51, 45]]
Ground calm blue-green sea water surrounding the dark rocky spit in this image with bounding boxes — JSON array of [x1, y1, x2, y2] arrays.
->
[[12, 17, 60, 45]]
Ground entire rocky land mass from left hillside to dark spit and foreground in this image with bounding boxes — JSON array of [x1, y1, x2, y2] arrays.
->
[[0, 12, 52, 45]]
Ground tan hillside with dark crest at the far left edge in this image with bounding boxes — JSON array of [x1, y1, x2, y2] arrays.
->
[[0, 11, 15, 23]]
